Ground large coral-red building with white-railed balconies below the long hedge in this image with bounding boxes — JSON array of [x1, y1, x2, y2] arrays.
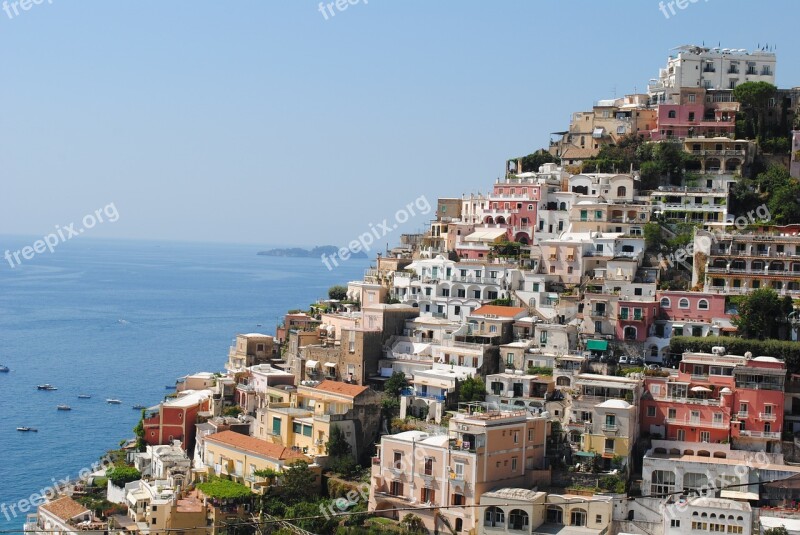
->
[[639, 354, 786, 452]]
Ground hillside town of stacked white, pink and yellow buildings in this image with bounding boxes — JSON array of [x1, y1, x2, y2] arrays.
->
[[20, 45, 800, 535]]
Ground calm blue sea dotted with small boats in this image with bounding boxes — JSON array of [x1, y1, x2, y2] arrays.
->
[[0, 237, 368, 530]]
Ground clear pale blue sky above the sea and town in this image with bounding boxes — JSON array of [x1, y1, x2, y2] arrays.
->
[[0, 0, 800, 246]]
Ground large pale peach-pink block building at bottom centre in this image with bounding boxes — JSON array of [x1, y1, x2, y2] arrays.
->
[[369, 403, 550, 533]]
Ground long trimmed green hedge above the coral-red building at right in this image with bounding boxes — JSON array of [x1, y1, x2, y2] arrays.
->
[[669, 336, 800, 373]]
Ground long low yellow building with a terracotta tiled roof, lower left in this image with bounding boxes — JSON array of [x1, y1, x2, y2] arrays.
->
[[202, 431, 321, 492]]
